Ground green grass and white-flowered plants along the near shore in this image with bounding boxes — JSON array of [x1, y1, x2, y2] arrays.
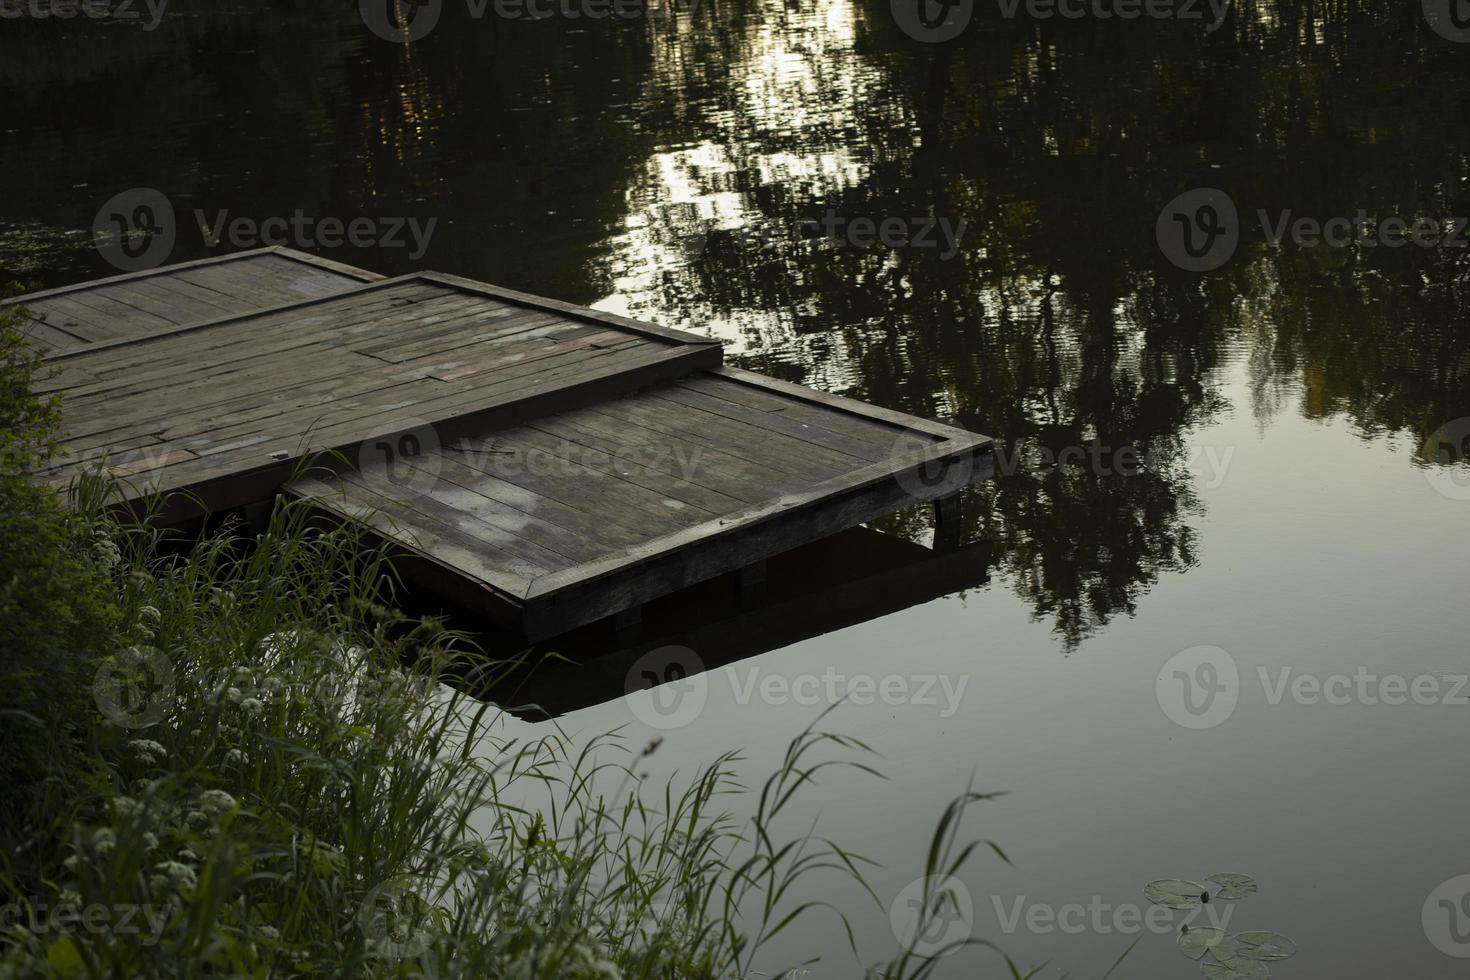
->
[[0, 310, 1033, 980]]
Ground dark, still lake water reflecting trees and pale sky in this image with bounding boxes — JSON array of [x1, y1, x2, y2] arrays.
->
[[0, 0, 1470, 980]]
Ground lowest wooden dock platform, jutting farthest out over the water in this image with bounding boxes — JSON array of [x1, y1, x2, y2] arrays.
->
[[287, 367, 989, 639]]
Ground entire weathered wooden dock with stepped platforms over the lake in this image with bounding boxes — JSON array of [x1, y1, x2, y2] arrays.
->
[[18, 250, 991, 639]]
